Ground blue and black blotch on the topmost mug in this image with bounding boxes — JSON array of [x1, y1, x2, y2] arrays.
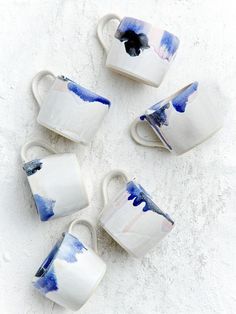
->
[[115, 18, 150, 57]]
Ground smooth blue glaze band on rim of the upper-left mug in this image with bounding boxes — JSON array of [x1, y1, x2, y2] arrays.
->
[[67, 79, 111, 107]]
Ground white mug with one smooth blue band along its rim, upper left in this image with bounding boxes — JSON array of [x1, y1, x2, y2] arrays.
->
[[32, 71, 111, 144]]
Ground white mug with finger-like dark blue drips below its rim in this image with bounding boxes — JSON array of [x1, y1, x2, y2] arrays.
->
[[99, 170, 174, 257]]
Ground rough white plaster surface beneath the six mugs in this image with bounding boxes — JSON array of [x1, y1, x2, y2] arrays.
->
[[0, 0, 236, 314]]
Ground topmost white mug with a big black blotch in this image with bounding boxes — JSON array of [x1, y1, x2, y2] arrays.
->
[[97, 14, 179, 87]]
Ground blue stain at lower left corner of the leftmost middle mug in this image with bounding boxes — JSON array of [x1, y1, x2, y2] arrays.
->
[[34, 194, 56, 221]]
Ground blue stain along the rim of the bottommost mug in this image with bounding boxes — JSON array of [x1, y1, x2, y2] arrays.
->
[[34, 233, 87, 294]]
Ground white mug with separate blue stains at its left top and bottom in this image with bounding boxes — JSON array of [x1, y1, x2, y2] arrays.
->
[[21, 140, 89, 221]]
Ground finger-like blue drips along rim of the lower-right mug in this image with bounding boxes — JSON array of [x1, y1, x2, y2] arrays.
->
[[127, 181, 174, 225]]
